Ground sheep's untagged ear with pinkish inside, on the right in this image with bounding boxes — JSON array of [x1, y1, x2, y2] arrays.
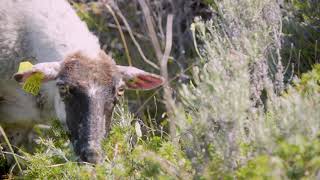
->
[[117, 65, 164, 90]]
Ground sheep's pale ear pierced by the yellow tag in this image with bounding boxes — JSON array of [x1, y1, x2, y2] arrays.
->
[[13, 62, 61, 82]]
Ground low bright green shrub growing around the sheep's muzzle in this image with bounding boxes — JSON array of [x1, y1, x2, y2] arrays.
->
[[12, 103, 193, 179]]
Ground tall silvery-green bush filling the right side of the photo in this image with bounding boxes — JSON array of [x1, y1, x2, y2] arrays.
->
[[176, 0, 320, 179]]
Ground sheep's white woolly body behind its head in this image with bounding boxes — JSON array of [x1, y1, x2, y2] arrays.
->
[[0, 0, 100, 124]]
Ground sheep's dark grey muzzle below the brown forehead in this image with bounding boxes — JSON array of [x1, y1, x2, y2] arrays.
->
[[64, 91, 113, 164]]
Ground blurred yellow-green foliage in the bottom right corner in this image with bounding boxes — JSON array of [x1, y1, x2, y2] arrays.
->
[[237, 136, 320, 179]]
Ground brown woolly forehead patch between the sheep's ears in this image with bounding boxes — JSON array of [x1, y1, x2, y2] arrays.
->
[[59, 52, 117, 87]]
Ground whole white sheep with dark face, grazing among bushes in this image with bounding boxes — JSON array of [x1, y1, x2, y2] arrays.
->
[[0, 0, 164, 163]]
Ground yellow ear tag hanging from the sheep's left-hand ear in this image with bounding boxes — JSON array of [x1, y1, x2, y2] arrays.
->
[[18, 61, 44, 96]]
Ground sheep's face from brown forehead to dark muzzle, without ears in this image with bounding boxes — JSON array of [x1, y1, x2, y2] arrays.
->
[[57, 52, 120, 163]]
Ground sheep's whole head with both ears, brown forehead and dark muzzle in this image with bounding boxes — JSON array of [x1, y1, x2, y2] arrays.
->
[[14, 53, 163, 163]]
